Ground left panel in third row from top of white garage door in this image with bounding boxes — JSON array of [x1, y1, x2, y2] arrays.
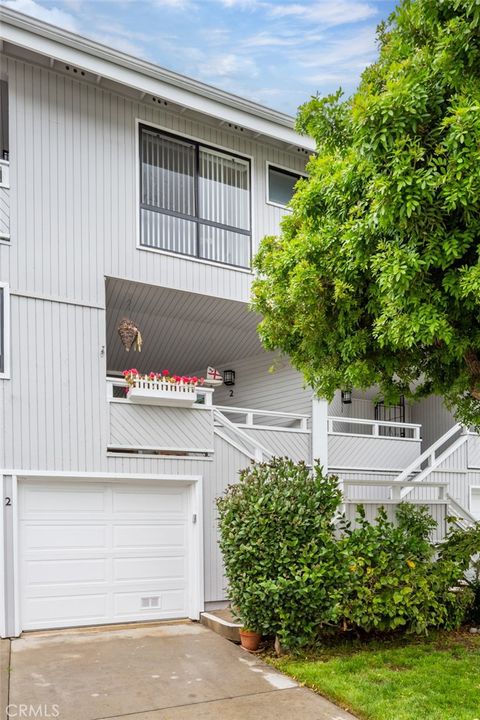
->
[[25, 558, 108, 588]]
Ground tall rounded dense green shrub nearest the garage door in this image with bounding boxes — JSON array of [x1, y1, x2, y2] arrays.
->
[[217, 459, 341, 645]]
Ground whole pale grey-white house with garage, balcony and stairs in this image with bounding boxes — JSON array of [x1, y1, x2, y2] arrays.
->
[[0, 7, 480, 636]]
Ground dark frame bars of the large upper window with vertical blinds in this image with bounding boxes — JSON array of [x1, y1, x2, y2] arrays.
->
[[139, 125, 252, 267]]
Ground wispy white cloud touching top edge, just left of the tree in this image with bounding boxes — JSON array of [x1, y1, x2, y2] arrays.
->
[[270, 0, 377, 27]]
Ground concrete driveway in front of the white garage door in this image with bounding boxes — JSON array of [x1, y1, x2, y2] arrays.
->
[[1, 623, 354, 720]]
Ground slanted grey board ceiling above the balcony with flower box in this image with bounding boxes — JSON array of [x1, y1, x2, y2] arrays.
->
[[106, 278, 263, 374]]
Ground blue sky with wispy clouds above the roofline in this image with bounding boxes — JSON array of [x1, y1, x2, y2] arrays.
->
[[0, 0, 395, 115]]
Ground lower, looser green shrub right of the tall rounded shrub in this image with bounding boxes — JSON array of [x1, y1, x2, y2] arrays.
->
[[340, 504, 464, 633]]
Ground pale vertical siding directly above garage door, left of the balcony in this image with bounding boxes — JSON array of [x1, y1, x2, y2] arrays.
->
[[0, 294, 107, 471]]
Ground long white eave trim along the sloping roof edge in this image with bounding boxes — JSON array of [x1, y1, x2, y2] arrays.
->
[[0, 6, 315, 151]]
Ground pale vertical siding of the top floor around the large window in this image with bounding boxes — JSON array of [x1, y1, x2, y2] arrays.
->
[[1, 58, 305, 303]]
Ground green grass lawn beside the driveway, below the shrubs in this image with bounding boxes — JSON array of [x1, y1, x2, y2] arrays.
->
[[266, 632, 480, 720]]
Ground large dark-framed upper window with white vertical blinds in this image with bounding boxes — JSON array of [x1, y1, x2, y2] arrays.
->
[[140, 126, 251, 267]]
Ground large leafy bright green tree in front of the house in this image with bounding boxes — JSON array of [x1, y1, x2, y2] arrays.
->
[[253, 0, 480, 427]]
